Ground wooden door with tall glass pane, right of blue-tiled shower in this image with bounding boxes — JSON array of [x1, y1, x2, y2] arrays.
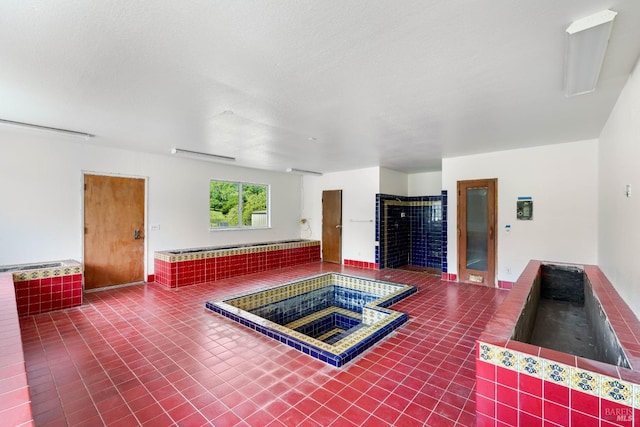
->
[[458, 179, 498, 287]]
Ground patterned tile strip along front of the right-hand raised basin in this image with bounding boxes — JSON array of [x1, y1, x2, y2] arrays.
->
[[477, 341, 640, 409]]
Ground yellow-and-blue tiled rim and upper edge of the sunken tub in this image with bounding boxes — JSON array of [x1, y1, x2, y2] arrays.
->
[[206, 273, 417, 367]]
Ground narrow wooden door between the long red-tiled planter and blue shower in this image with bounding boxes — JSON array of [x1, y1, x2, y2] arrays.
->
[[322, 190, 342, 264]]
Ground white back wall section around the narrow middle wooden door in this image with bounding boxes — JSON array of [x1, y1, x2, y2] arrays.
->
[[301, 167, 380, 262]]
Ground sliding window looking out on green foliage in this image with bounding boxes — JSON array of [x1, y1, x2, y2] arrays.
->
[[209, 180, 269, 229]]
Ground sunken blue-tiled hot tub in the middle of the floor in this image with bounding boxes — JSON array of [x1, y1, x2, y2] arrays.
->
[[206, 273, 416, 367]]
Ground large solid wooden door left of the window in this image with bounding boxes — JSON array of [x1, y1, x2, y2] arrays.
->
[[84, 175, 145, 289]]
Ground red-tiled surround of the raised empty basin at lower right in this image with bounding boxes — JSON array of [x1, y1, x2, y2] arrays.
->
[[476, 261, 640, 427]]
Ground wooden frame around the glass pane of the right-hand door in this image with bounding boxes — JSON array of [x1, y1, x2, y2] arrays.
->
[[456, 178, 498, 288]]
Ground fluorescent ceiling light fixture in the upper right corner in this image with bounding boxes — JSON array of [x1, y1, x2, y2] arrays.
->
[[564, 10, 617, 96]]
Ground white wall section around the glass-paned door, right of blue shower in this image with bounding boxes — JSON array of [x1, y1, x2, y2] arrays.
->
[[442, 140, 598, 281]]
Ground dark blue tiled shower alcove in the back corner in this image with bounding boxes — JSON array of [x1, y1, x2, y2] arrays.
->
[[376, 195, 446, 269]]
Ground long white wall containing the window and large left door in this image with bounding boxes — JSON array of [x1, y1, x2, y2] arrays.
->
[[0, 129, 301, 274]]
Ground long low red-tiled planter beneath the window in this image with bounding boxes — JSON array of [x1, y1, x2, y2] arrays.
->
[[154, 240, 320, 288]]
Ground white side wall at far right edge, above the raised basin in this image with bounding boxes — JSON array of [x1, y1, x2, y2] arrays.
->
[[598, 61, 640, 318]]
